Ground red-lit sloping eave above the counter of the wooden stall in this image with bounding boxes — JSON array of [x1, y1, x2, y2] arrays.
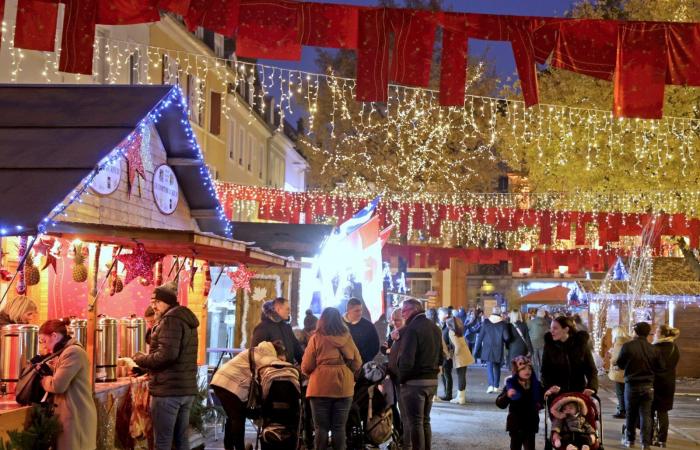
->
[[49, 222, 294, 267]]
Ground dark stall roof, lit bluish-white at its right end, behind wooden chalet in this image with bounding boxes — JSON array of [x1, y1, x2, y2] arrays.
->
[[233, 222, 333, 257]]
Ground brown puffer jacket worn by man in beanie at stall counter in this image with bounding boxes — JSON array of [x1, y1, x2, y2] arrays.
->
[[134, 305, 199, 397]]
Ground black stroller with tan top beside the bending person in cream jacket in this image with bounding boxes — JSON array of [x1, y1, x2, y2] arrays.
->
[[253, 363, 302, 450]]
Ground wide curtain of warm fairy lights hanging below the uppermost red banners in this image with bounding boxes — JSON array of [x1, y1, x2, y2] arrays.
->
[[2, 27, 700, 191]]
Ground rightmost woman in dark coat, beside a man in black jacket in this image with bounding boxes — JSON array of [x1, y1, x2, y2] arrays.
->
[[652, 325, 681, 447]]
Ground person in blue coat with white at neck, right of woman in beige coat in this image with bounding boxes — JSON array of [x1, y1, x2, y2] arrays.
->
[[474, 307, 511, 394]]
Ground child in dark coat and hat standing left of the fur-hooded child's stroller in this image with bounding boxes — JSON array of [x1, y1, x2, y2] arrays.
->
[[496, 356, 544, 450]]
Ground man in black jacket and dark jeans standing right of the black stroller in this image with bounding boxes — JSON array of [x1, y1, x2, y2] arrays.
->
[[398, 299, 443, 450]]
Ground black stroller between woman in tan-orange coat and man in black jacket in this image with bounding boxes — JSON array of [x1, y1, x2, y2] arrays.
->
[[347, 361, 400, 450]]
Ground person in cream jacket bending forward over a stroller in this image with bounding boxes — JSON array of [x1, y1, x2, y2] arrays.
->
[[210, 341, 287, 450]]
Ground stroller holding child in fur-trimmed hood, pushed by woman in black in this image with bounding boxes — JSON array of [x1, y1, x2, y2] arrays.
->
[[549, 393, 601, 450]]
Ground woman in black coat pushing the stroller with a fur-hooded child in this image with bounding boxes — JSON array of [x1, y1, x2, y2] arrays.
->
[[542, 316, 598, 395]]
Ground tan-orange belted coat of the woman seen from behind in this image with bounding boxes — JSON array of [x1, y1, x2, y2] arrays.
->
[[301, 332, 362, 398]]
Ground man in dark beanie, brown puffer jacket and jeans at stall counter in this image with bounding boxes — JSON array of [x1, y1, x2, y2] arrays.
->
[[134, 282, 199, 450]]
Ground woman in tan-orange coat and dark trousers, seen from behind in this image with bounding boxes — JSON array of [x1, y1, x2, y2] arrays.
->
[[301, 308, 362, 450]]
